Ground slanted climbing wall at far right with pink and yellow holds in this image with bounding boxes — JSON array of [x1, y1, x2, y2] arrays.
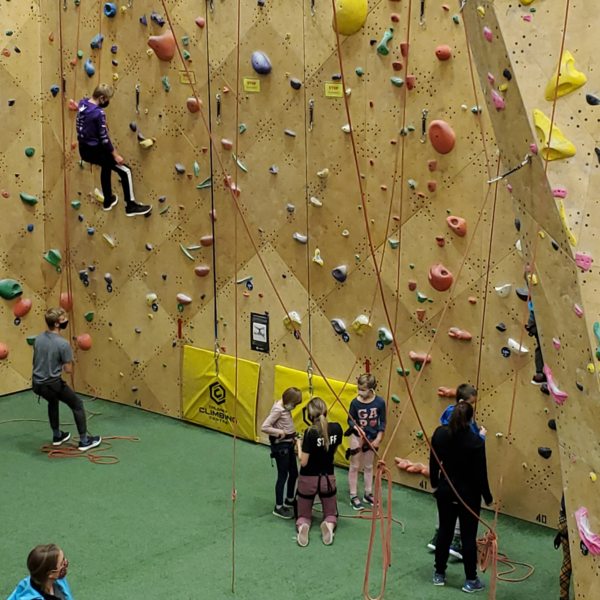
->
[[465, 2, 600, 598]]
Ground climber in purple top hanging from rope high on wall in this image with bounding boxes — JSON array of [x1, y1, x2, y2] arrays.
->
[[77, 83, 152, 217]]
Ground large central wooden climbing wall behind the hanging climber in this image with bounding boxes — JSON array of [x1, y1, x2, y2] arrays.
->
[[0, 0, 584, 525]]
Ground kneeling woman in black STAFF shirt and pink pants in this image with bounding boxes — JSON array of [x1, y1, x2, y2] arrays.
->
[[296, 398, 343, 547]]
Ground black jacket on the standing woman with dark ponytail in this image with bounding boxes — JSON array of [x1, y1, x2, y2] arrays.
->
[[429, 425, 493, 504]]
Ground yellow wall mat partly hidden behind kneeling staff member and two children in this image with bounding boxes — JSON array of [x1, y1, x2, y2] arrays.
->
[[275, 365, 358, 466]]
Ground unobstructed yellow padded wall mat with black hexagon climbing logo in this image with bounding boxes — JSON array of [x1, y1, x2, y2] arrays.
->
[[182, 346, 260, 442]]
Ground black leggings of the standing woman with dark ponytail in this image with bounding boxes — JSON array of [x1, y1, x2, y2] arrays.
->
[[435, 480, 481, 579]]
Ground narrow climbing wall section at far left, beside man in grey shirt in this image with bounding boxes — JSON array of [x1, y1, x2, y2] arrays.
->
[[0, 2, 47, 394]]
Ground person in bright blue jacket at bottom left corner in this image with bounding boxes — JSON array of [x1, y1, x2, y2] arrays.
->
[[8, 544, 73, 600]]
